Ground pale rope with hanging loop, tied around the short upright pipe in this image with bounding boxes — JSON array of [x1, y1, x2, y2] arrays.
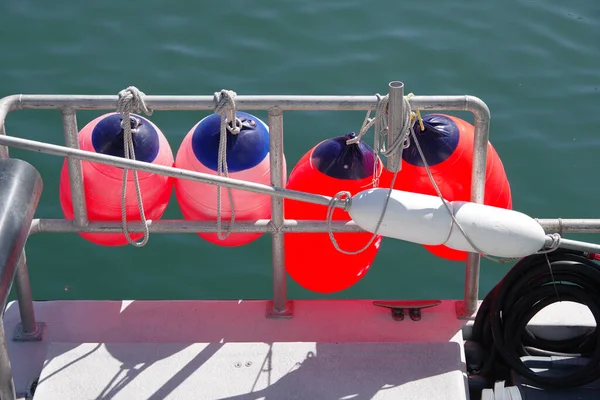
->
[[326, 94, 412, 255]]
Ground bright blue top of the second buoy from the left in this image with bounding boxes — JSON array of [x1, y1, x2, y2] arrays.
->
[[192, 111, 269, 172]]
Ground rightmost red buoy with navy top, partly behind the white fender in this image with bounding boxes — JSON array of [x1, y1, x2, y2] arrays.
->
[[379, 114, 512, 261]]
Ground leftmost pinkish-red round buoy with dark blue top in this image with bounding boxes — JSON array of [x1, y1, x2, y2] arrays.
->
[[60, 113, 173, 246]]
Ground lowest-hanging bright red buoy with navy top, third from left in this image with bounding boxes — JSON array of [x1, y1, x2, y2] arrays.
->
[[284, 133, 382, 293]]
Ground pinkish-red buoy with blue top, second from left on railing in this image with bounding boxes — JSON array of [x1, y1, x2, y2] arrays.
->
[[175, 111, 285, 247]]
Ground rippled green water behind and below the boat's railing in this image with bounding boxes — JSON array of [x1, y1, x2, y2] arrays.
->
[[0, 0, 600, 299]]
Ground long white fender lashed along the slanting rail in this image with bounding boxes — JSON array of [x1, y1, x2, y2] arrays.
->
[[348, 188, 546, 258]]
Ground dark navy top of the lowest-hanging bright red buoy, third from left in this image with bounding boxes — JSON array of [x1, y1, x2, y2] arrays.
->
[[311, 132, 375, 180]]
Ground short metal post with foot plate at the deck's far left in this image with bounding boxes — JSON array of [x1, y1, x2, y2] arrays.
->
[[13, 250, 45, 342]]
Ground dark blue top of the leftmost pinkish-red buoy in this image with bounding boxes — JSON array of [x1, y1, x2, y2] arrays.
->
[[92, 114, 160, 163]]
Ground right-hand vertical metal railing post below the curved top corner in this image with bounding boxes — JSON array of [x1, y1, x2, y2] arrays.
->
[[458, 100, 490, 317]]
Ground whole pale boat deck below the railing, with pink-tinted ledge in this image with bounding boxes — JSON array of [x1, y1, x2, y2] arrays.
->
[[4, 300, 595, 400]]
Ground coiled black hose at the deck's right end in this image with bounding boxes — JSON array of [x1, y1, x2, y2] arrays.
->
[[473, 249, 600, 388]]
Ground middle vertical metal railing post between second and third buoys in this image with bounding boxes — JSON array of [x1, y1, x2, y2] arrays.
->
[[267, 107, 292, 318]]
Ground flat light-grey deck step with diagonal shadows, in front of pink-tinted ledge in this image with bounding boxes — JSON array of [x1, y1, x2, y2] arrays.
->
[[34, 342, 467, 400]]
